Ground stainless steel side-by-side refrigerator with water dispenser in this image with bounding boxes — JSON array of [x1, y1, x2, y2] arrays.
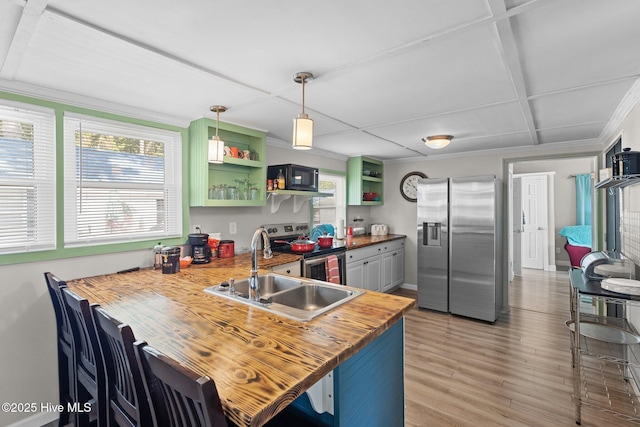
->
[[417, 175, 503, 322]]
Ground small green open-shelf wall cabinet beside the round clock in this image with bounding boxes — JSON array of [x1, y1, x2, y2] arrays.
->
[[347, 156, 384, 205]]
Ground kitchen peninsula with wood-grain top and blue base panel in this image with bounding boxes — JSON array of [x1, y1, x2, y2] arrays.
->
[[68, 255, 415, 426]]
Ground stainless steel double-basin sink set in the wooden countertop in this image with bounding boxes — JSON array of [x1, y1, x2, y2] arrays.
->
[[205, 273, 364, 322]]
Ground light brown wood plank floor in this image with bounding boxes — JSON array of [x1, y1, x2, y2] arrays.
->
[[396, 270, 640, 427]]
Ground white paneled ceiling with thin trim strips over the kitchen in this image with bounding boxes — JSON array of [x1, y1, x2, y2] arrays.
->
[[0, 0, 640, 159]]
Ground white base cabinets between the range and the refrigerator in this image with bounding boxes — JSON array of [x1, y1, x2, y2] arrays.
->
[[347, 239, 404, 292]]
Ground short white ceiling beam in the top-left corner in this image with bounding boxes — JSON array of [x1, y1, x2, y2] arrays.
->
[[0, 0, 49, 80]]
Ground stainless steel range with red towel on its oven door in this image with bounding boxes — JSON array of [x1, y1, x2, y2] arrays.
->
[[262, 223, 347, 285]]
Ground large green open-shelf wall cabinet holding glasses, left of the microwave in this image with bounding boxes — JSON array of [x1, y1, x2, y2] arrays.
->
[[189, 117, 267, 206]]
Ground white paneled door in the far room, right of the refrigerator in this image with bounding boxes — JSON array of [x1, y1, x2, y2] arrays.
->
[[514, 175, 547, 270]]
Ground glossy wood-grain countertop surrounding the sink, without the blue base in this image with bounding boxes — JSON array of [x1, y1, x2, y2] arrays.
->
[[68, 258, 415, 426]]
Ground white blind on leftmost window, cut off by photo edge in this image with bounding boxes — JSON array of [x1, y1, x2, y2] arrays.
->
[[0, 101, 56, 254]]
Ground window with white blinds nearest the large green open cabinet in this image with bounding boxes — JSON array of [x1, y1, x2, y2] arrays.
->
[[64, 116, 182, 247]]
